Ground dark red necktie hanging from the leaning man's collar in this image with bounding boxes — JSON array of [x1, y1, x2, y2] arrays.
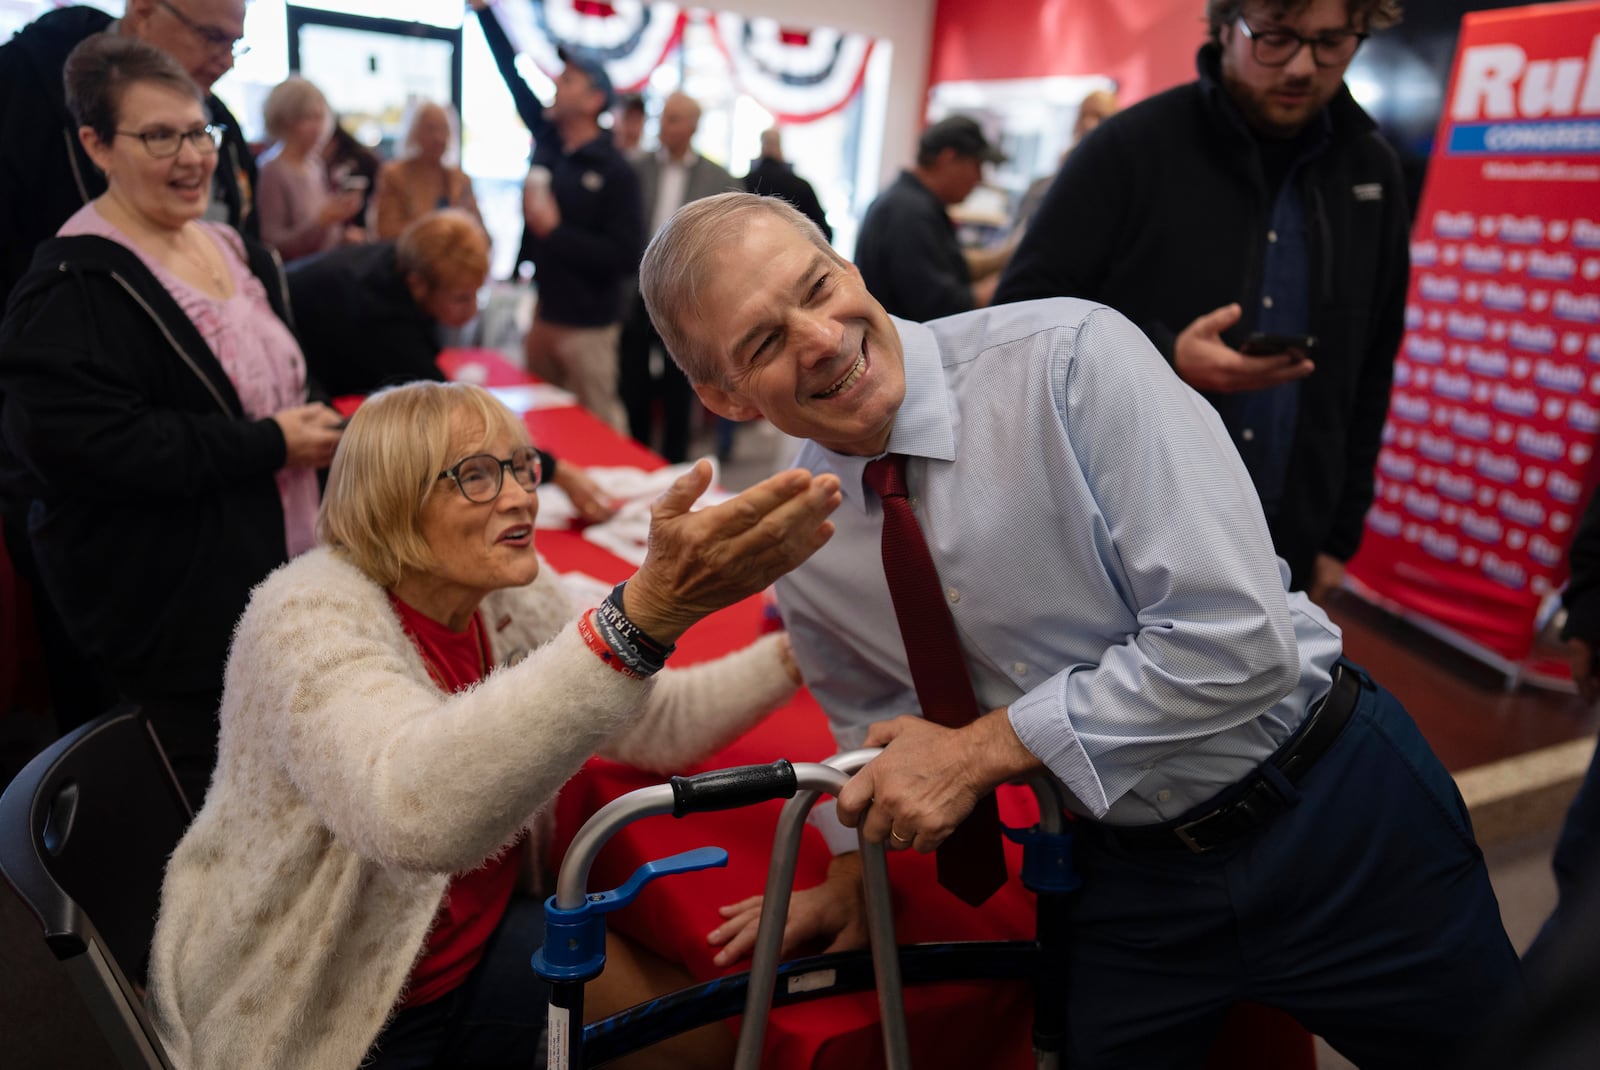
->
[[866, 454, 1006, 907]]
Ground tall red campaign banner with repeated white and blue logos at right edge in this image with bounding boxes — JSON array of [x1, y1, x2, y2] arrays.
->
[[1350, 3, 1600, 662]]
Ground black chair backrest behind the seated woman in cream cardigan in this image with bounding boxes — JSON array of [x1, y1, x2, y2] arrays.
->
[[0, 707, 194, 1068]]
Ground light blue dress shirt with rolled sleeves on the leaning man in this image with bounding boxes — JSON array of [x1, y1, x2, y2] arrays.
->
[[778, 299, 1341, 825]]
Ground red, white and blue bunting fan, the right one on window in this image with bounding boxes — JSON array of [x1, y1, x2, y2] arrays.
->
[[710, 13, 872, 123]]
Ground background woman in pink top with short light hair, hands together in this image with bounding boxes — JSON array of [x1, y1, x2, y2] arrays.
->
[[256, 75, 362, 261]]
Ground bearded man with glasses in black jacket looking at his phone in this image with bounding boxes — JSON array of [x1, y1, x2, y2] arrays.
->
[[995, 0, 1410, 598]]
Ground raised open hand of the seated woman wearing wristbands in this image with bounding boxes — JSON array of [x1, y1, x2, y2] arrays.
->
[[622, 461, 840, 643]]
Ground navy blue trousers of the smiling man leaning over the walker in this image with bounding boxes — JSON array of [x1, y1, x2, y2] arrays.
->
[[1066, 673, 1520, 1070]]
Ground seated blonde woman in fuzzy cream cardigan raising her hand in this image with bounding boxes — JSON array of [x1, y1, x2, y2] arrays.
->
[[149, 382, 840, 1070]]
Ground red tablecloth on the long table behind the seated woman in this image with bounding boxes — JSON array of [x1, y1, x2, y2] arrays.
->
[[440, 350, 1315, 1070]]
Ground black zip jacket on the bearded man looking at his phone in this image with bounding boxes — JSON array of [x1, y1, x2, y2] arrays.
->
[[995, 45, 1410, 589]]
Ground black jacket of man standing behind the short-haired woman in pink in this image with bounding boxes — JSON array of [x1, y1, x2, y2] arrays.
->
[[0, 6, 259, 309]]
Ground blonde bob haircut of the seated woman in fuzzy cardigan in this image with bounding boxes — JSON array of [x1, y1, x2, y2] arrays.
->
[[317, 382, 528, 587]]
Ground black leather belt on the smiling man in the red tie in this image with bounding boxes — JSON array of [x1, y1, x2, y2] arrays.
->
[[1100, 661, 1362, 854]]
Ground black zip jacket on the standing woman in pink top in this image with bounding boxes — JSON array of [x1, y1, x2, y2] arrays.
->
[[0, 235, 297, 699]]
